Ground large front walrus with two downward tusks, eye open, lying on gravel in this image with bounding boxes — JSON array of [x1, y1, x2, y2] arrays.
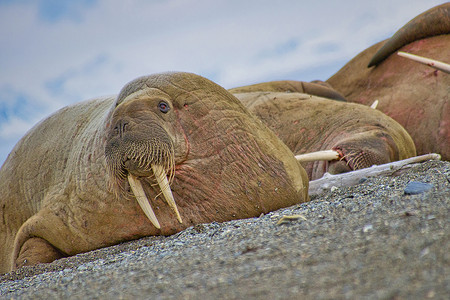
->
[[0, 72, 309, 272]]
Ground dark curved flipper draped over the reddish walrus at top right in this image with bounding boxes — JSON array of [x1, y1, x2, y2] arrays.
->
[[367, 2, 450, 68]]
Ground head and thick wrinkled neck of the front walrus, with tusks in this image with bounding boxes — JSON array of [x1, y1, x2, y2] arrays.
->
[[105, 73, 307, 233]]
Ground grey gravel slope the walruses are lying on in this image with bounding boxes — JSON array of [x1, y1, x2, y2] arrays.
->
[[0, 161, 450, 299]]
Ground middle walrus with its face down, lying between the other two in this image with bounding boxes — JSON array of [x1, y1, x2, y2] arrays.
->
[[234, 92, 416, 180]]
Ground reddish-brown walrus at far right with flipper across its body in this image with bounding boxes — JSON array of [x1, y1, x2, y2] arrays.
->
[[326, 3, 450, 160]]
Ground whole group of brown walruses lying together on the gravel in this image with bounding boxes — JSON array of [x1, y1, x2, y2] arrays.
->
[[0, 3, 450, 273]]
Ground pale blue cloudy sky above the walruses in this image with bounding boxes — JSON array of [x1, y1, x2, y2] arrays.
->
[[0, 0, 446, 165]]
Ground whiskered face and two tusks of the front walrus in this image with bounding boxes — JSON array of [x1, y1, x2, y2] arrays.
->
[[105, 82, 182, 228]]
